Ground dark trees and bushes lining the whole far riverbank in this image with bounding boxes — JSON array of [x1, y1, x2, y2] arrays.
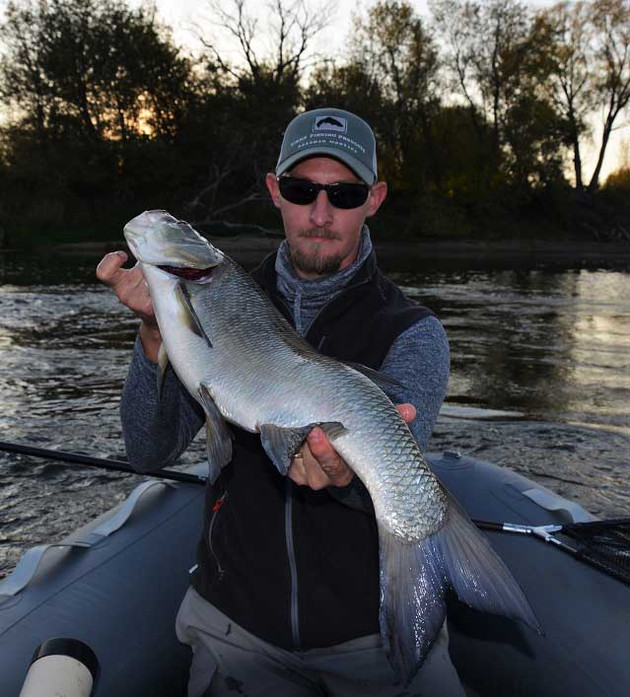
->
[[0, 0, 630, 250]]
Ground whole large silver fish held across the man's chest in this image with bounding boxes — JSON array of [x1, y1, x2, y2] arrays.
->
[[124, 211, 538, 684]]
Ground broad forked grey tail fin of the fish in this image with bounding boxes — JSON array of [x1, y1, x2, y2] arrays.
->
[[379, 495, 541, 685]]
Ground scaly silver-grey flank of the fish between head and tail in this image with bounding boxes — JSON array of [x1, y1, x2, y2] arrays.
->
[[191, 261, 444, 541]]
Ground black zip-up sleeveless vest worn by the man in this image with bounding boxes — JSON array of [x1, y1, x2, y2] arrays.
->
[[193, 253, 432, 650]]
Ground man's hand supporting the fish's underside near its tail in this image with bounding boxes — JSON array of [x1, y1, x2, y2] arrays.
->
[[288, 404, 416, 491]]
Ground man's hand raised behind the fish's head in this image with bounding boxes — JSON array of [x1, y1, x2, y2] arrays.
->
[[96, 252, 162, 363]]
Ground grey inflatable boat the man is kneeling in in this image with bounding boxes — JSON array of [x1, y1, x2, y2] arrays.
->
[[0, 452, 630, 697]]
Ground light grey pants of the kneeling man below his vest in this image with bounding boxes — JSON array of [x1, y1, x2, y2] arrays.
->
[[176, 588, 465, 697]]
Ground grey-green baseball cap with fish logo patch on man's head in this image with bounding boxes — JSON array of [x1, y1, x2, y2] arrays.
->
[[276, 109, 377, 186]]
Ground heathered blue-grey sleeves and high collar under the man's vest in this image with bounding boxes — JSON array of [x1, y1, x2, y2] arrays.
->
[[121, 227, 449, 470]]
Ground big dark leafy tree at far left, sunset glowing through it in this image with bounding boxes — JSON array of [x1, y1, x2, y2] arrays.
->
[[0, 0, 194, 224]]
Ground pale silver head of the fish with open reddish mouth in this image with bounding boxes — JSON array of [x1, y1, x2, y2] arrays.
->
[[124, 210, 225, 280]]
